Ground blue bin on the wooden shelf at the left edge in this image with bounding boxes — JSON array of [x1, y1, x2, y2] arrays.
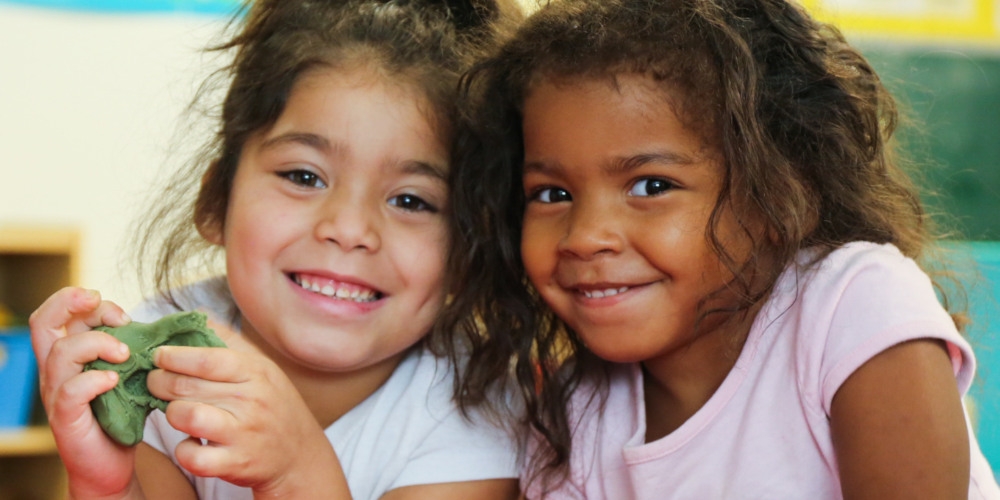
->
[[0, 328, 38, 428]]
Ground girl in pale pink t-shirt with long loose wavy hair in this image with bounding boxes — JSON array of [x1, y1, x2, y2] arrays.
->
[[446, 0, 1000, 499]]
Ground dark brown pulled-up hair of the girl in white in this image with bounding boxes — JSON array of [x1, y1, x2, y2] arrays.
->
[[134, 0, 523, 326]]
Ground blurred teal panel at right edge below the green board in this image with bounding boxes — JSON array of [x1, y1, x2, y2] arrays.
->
[[954, 241, 1000, 477]]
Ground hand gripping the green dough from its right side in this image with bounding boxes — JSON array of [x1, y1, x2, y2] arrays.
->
[[147, 322, 349, 498]]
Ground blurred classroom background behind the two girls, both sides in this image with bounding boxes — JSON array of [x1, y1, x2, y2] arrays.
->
[[0, 0, 1000, 500]]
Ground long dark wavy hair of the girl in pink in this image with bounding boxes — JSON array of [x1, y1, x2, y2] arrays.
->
[[442, 0, 960, 488]]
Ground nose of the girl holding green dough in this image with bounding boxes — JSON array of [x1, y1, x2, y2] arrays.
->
[[315, 193, 382, 252]]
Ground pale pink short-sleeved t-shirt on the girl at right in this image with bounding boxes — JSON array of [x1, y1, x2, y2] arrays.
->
[[522, 242, 1000, 500]]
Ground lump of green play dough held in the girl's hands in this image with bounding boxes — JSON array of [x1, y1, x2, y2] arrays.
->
[[84, 312, 226, 446]]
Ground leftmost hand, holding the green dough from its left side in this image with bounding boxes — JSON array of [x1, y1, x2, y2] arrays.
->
[[29, 288, 137, 498]]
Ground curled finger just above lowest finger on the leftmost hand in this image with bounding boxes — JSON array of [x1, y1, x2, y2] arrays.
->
[[38, 331, 129, 393]]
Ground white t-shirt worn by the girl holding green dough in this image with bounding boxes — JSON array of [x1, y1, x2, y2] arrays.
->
[[132, 280, 518, 500]]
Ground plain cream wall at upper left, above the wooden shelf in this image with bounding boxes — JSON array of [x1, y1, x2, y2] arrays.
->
[[0, 4, 223, 307]]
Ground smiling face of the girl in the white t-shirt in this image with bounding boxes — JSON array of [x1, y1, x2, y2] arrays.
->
[[218, 68, 448, 372]]
